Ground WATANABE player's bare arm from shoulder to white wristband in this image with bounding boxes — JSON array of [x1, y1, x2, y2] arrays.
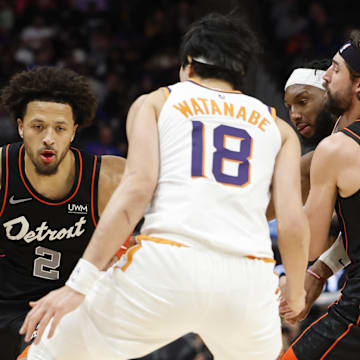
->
[[84, 90, 165, 269]]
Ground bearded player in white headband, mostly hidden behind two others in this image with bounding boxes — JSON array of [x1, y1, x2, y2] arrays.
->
[[280, 59, 350, 323]]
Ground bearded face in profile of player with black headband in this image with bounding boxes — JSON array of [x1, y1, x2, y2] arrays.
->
[[324, 54, 353, 116]]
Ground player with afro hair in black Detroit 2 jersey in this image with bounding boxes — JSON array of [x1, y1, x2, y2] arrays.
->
[[0, 67, 125, 360]]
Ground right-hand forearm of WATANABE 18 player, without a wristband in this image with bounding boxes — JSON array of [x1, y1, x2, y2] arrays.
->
[[278, 219, 310, 294]]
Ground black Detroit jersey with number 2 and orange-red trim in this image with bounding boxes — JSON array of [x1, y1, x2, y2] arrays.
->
[[0, 143, 101, 318]]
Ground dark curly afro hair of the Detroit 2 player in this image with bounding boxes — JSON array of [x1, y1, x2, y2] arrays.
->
[[0, 66, 97, 127]]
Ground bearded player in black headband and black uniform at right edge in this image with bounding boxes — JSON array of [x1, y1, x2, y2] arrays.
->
[[282, 31, 360, 360]]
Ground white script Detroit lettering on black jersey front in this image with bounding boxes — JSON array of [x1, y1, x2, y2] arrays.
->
[[3, 216, 86, 243]]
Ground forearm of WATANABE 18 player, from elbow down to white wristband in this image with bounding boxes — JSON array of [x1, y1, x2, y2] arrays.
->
[[83, 179, 152, 270]]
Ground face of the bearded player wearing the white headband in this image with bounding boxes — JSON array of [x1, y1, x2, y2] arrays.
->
[[284, 84, 325, 138]]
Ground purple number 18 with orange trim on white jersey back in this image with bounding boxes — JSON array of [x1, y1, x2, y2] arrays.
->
[[191, 121, 252, 187]]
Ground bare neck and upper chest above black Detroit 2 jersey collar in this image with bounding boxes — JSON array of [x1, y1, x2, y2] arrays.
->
[[25, 150, 75, 200]]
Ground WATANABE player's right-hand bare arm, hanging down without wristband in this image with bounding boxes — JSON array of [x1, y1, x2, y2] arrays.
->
[[272, 119, 310, 316]]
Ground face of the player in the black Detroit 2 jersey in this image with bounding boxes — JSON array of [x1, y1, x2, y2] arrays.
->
[[18, 101, 77, 175]]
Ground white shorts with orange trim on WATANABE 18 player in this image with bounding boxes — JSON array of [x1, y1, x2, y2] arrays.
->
[[29, 237, 282, 360]]
